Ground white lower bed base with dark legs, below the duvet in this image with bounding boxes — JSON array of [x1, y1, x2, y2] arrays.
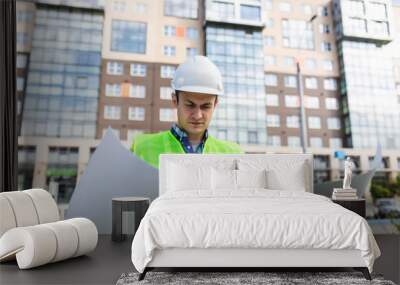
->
[[139, 248, 371, 281]]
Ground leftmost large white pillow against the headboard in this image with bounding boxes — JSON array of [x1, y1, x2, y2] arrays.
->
[[166, 163, 211, 191]]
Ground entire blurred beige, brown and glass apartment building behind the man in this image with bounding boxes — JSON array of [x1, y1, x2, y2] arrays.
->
[[17, 0, 400, 203]]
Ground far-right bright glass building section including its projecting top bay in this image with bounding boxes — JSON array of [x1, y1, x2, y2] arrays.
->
[[333, 0, 400, 149]]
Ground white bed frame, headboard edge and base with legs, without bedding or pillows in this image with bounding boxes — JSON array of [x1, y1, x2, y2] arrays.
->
[[139, 154, 371, 280]]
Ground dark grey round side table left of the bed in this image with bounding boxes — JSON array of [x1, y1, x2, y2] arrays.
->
[[111, 197, 150, 241]]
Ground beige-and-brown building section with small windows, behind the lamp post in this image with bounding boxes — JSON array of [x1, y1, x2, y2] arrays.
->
[[263, 0, 343, 149]]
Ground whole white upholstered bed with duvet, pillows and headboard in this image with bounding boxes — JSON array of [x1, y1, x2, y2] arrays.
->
[[132, 154, 380, 280]]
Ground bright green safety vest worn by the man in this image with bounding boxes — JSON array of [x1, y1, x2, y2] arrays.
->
[[131, 131, 243, 168]]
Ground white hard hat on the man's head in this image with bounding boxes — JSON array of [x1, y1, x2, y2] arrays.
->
[[171, 55, 224, 95]]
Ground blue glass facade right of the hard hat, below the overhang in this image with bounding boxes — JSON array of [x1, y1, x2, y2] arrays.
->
[[206, 24, 267, 144]]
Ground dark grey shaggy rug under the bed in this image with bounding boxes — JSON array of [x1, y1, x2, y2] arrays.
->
[[116, 272, 396, 285]]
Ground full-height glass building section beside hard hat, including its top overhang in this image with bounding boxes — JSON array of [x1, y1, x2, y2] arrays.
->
[[204, 0, 267, 145]]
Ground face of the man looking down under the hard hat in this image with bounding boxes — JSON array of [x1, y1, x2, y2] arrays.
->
[[172, 91, 217, 138]]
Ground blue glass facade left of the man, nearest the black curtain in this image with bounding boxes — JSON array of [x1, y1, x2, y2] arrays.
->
[[21, 6, 103, 138]]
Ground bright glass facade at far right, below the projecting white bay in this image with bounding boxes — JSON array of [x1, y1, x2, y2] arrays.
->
[[339, 41, 400, 149]]
